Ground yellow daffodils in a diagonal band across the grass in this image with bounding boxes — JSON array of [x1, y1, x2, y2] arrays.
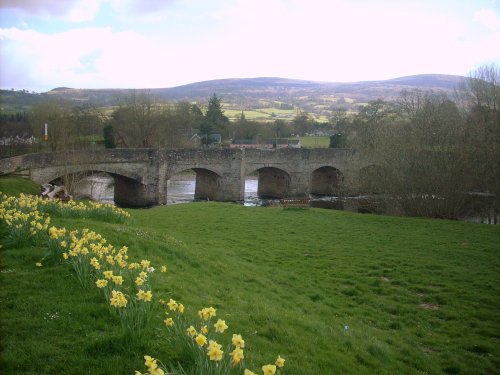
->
[[0, 193, 285, 375]]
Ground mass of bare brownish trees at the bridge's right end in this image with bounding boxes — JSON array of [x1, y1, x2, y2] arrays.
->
[[331, 66, 500, 220]]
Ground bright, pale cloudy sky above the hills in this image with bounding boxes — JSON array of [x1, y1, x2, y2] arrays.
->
[[0, 0, 500, 92]]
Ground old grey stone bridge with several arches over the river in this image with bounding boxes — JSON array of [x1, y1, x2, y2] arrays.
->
[[0, 149, 373, 207]]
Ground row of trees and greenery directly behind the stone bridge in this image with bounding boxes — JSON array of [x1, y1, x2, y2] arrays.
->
[[0, 90, 330, 152]]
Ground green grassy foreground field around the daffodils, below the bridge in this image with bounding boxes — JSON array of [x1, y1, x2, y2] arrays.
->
[[0, 180, 500, 375]]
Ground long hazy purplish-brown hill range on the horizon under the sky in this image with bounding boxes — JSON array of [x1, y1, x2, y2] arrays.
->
[[0, 74, 464, 115]]
